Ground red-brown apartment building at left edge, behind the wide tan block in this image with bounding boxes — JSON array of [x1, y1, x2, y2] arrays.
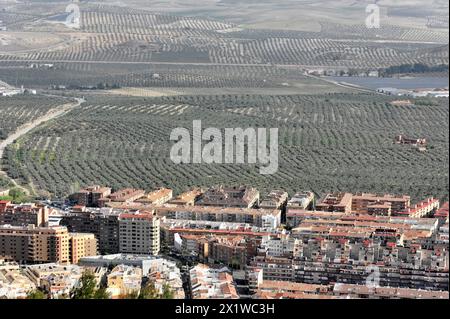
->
[[0, 201, 50, 227]]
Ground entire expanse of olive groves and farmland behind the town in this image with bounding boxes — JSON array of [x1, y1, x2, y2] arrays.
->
[[0, 0, 449, 205]]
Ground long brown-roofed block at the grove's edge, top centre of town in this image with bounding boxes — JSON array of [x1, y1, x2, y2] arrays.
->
[[196, 186, 260, 208]]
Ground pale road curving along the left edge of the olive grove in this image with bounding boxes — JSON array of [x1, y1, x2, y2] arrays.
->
[[0, 98, 85, 194]]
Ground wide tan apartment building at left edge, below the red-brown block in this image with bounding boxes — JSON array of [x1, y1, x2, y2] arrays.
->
[[0, 225, 70, 263]]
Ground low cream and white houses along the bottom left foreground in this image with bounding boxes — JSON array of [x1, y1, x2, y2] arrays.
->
[[0, 254, 185, 299]]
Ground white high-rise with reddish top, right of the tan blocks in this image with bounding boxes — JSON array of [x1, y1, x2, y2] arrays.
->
[[119, 213, 160, 255]]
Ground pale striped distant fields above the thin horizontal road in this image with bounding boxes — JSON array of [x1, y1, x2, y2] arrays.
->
[[0, 2, 448, 80]]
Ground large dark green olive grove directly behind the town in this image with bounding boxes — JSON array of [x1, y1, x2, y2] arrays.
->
[[4, 93, 449, 200]]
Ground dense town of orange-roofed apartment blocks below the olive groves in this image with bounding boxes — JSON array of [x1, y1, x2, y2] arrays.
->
[[0, 186, 449, 298]]
